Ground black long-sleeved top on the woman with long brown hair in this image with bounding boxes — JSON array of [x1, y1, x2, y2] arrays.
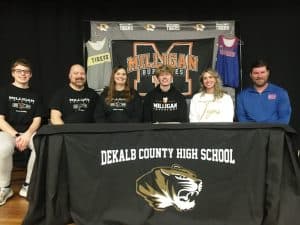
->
[[95, 88, 143, 123]]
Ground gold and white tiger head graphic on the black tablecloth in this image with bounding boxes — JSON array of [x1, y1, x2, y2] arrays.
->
[[136, 165, 202, 211]]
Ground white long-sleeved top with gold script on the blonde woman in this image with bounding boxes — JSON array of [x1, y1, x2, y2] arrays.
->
[[189, 92, 234, 122]]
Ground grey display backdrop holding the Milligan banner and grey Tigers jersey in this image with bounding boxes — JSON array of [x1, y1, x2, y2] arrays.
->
[[86, 21, 234, 97]]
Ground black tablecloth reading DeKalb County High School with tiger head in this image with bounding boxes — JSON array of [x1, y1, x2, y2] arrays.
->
[[24, 124, 300, 225]]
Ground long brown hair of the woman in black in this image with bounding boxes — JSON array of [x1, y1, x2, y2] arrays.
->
[[105, 66, 133, 104]]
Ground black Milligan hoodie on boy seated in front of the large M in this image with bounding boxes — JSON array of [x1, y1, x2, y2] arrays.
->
[[144, 86, 188, 123]]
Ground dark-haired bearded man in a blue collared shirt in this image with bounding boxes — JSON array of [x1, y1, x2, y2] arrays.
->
[[236, 60, 291, 124]]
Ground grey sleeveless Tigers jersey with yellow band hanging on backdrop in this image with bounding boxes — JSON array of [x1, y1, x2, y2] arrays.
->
[[86, 38, 112, 92]]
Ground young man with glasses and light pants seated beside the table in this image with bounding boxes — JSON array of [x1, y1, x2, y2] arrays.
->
[[0, 59, 43, 206]]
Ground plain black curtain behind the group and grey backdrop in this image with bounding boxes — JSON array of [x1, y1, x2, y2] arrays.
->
[[0, 3, 300, 146]]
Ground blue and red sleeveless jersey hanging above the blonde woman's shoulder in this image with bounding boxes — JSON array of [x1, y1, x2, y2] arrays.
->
[[216, 35, 239, 88]]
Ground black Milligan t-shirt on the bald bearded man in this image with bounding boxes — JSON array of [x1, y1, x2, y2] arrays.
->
[[49, 86, 99, 123]]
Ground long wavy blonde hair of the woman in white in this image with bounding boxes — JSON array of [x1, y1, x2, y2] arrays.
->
[[199, 68, 225, 99]]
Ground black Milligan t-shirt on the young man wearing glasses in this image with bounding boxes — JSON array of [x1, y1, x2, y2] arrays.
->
[[0, 84, 43, 132]]
